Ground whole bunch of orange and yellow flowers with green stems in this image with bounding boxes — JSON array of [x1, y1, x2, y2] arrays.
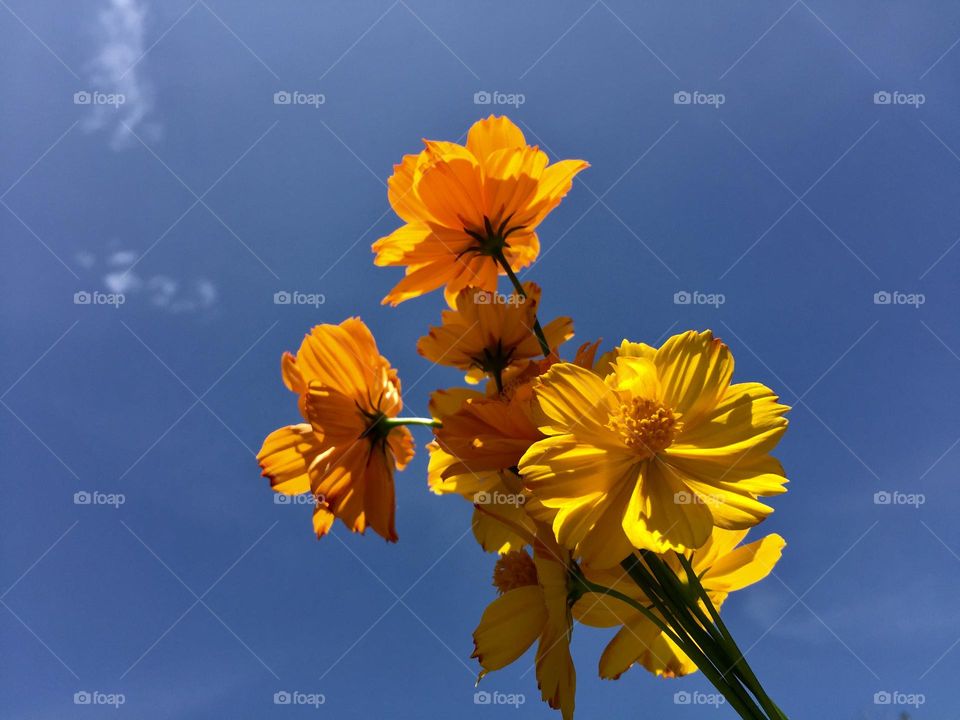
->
[[258, 116, 789, 720]]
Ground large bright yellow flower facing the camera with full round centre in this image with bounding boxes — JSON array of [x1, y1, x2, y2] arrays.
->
[[520, 331, 789, 567]]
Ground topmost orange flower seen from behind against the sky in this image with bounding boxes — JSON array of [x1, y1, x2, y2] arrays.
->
[[373, 115, 587, 306]]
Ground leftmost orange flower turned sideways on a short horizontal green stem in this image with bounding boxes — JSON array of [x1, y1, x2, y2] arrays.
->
[[257, 318, 414, 542]]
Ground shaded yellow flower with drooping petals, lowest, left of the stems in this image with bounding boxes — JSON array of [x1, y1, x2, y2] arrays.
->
[[473, 543, 577, 720]]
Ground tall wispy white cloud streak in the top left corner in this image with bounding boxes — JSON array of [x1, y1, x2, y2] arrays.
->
[[79, 0, 159, 150]]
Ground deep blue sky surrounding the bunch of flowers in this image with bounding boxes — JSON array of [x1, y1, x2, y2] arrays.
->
[[0, 0, 960, 720]]
